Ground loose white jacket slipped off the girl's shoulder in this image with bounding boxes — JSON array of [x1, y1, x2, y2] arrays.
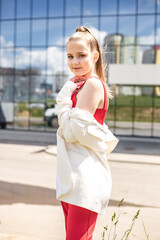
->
[[56, 81, 118, 214]]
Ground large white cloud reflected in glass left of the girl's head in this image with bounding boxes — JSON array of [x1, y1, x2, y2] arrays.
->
[[0, 36, 67, 74]]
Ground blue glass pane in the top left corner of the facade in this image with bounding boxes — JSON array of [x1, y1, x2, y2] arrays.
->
[[1, 0, 15, 19]]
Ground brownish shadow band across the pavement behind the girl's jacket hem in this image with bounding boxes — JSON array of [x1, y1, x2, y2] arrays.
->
[[0, 181, 159, 208]]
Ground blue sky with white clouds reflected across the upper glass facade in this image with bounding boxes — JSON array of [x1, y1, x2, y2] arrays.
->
[[0, 0, 160, 75]]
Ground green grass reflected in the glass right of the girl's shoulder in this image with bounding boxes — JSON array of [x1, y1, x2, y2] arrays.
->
[[106, 96, 160, 122]]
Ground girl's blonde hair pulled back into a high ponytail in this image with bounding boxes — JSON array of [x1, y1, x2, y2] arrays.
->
[[67, 26, 112, 98]]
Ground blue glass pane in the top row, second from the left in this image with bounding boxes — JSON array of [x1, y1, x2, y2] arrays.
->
[[17, 0, 31, 18]]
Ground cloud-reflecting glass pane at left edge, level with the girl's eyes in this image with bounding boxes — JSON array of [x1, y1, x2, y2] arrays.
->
[[0, 48, 14, 68]]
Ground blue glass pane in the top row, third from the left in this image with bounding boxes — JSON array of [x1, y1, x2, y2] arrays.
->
[[32, 0, 47, 18]]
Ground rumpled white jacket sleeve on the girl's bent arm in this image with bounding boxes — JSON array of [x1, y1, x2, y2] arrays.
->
[[56, 81, 117, 152]]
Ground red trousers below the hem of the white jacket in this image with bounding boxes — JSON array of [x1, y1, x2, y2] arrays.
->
[[61, 202, 98, 240]]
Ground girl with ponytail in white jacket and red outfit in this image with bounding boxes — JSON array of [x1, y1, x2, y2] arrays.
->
[[57, 26, 118, 240]]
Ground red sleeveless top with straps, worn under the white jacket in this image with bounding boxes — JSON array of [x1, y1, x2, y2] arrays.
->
[[71, 77, 108, 125]]
